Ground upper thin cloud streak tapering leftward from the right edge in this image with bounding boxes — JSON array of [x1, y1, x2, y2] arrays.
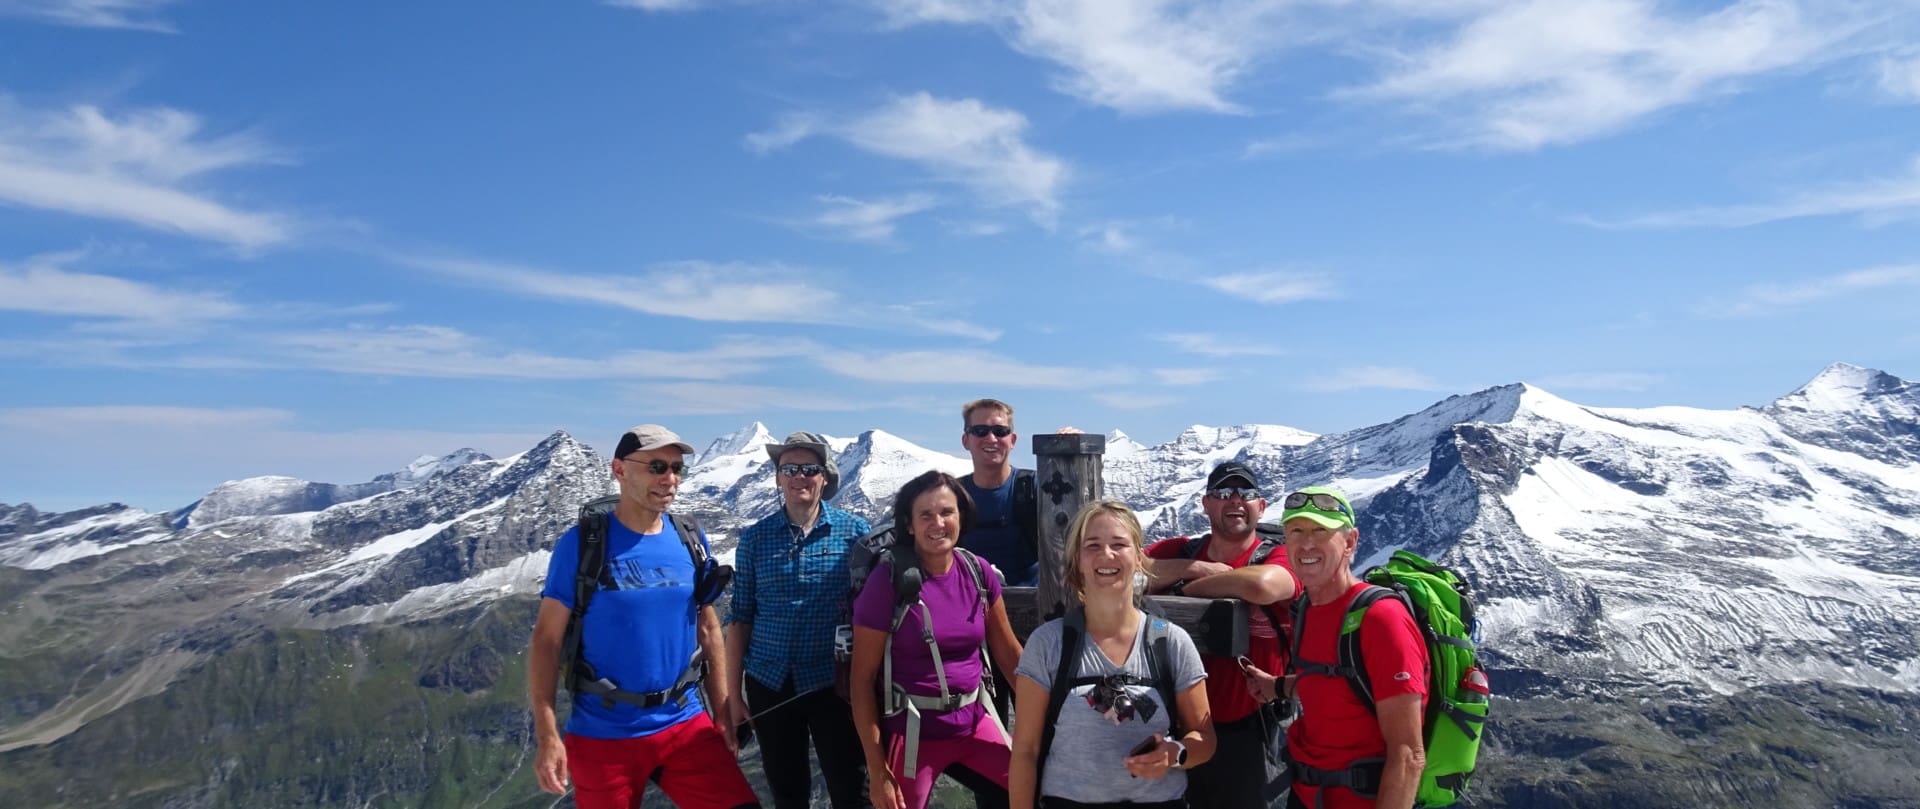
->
[[1574, 158, 1920, 229]]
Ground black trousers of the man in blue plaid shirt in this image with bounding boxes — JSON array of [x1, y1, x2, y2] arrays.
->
[[747, 674, 868, 809]]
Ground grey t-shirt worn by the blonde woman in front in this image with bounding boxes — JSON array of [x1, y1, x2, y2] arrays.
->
[[1014, 617, 1206, 803]]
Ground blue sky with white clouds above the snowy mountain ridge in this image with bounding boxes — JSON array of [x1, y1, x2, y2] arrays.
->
[[0, 0, 1920, 509]]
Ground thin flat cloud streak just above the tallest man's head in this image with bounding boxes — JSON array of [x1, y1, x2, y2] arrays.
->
[[814, 350, 1137, 388]]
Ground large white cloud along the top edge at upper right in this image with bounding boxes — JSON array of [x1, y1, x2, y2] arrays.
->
[[1348, 0, 1866, 150]]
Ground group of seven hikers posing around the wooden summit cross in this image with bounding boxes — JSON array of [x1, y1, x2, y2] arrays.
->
[[528, 400, 1486, 809]]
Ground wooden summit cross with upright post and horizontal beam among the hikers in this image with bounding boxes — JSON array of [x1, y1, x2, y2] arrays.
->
[[1004, 432, 1248, 657]]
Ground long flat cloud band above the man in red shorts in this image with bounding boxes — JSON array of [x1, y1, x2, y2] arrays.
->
[[261, 325, 812, 380]]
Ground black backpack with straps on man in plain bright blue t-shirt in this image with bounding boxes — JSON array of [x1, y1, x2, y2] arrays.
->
[[561, 494, 733, 707]]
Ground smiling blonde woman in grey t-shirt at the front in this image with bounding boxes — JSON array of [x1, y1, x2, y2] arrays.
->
[[1008, 500, 1213, 809]]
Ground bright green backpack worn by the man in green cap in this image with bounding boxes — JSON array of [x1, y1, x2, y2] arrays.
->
[[1292, 552, 1490, 807]]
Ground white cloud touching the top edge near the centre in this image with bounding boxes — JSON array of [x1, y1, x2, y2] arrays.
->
[[876, 0, 1281, 113]]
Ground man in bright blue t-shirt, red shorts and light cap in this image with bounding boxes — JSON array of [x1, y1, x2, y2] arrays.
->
[[528, 425, 760, 809]]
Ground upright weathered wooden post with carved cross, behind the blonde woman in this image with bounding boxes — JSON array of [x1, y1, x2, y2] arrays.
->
[[1033, 432, 1106, 615]]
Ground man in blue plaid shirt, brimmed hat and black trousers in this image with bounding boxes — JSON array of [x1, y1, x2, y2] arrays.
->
[[726, 432, 870, 809]]
